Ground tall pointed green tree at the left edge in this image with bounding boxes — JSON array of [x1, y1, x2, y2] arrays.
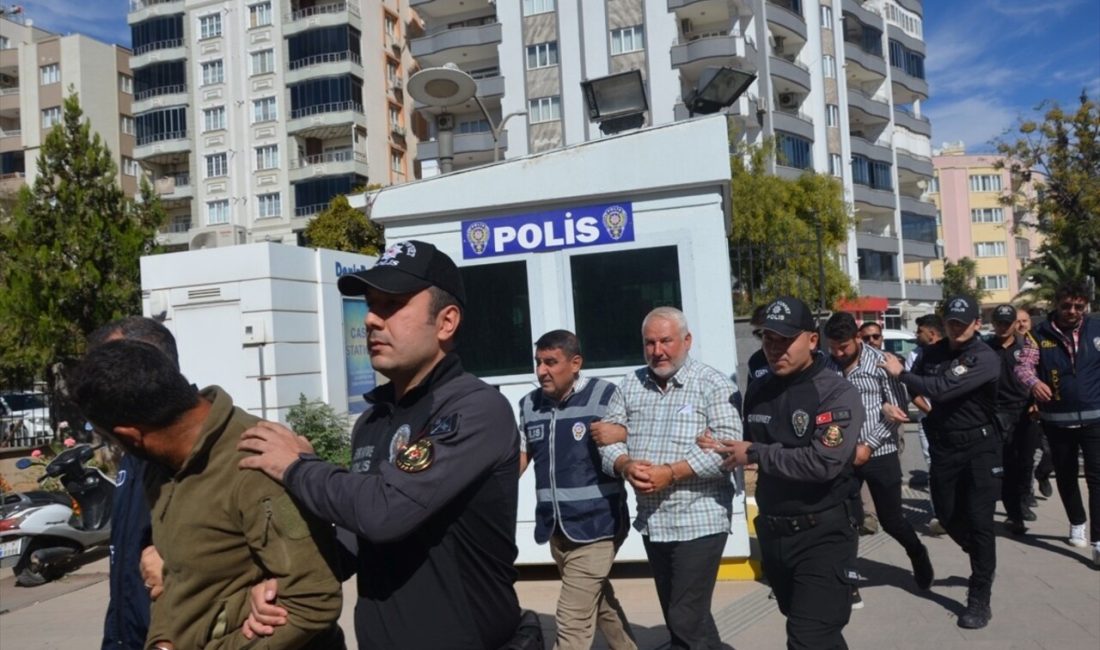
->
[[0, 93, 165, 384]]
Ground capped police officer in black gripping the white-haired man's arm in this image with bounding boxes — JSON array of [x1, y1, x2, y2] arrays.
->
[[700, 297, 865, 650]]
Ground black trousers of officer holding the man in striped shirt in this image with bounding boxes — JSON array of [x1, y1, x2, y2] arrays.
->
[[930, 434, 1003, 599]]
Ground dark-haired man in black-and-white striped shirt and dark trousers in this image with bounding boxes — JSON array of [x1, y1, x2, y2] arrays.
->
[[825, 311, 933, 601]]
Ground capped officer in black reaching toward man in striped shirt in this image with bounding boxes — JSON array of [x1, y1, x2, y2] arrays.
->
[[882, 296, 1004, 629]]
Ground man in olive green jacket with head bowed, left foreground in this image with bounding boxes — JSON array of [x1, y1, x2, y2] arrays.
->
[[70, 340, 343, 650]]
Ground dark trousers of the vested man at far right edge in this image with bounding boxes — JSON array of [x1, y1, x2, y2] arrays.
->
[[1043, 422, 1100, 543]]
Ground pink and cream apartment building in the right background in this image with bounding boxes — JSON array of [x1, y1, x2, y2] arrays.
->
[[905, 142, 1043, 309]]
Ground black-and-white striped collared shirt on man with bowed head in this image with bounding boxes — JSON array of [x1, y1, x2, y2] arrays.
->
[[826, 343, 905, 458]]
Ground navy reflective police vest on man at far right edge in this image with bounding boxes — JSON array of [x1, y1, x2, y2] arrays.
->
[[1035, 317, 1100, 427]]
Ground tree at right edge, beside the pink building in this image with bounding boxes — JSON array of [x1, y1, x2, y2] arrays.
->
[[997, 92, 1100, 292]]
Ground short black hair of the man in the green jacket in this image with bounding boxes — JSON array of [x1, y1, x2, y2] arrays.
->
[[69, 339, 199, 431]]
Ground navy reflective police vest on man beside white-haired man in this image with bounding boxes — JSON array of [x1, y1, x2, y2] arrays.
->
[[519, 378, 626, 544]]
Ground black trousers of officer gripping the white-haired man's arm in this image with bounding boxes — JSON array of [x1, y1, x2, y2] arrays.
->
[[756, 510, 859, 650]]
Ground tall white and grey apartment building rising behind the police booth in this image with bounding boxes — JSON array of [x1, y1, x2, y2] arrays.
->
[[409, 0, 941, 312]]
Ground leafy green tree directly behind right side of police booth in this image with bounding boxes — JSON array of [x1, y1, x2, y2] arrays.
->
[[729, 137, 854, 313]]
